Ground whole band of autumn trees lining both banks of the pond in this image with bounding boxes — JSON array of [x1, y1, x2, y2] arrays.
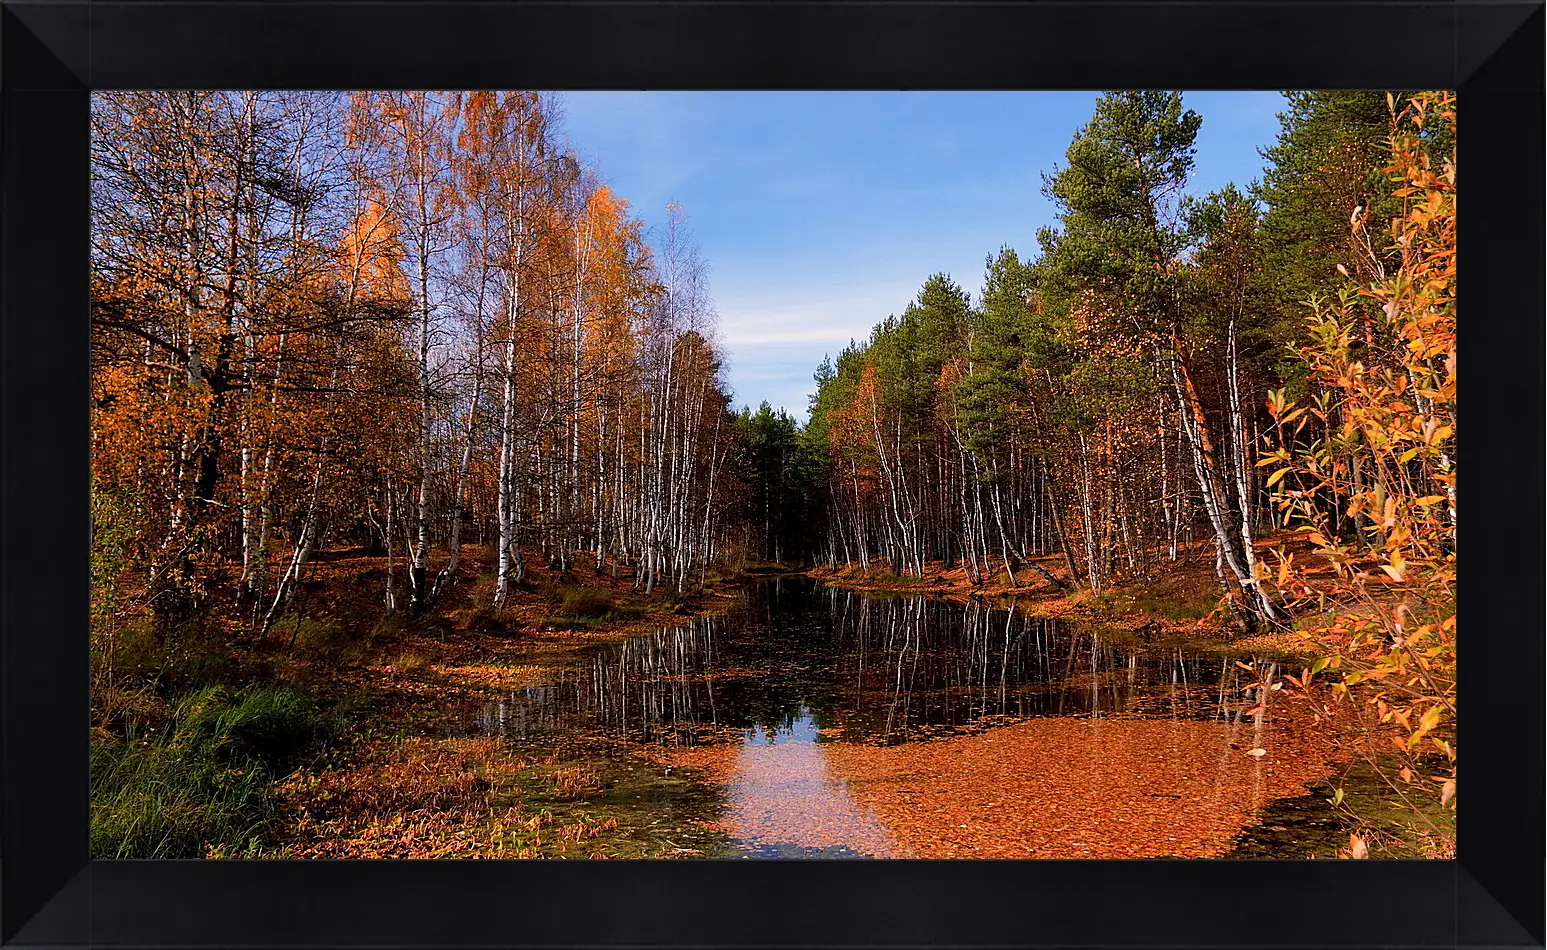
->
[[91, 91, 1454, 646]]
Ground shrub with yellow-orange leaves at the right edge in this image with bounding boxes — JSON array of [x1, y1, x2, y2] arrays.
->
[[1261, 93, 1456, 829]]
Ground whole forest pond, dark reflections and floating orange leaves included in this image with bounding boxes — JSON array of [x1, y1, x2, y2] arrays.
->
[[478, 577, 1327, 857]]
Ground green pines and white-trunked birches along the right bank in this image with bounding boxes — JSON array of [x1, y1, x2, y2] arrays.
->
[[792, 91, 1454, 625]]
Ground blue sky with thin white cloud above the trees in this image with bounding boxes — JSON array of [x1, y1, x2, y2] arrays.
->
[[560, 91, 1282, 421]]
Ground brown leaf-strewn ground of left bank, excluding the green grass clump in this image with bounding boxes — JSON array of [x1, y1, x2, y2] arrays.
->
[[93, 546, 743, 859]]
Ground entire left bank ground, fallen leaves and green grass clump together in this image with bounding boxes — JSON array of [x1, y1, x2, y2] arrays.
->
[[93, 545, 744, 859]]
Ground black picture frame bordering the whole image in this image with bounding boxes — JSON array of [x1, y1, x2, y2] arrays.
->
[[0, 0, 1547, 948]]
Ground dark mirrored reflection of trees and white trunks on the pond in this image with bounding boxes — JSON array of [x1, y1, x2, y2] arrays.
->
[[481, 579, 1293, 744]]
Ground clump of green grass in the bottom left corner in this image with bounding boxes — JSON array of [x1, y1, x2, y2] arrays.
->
[[91, 685, 331, 859]]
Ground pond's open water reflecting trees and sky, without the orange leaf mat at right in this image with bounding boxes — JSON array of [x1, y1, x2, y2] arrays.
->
[[480, 579, 1311, 857]]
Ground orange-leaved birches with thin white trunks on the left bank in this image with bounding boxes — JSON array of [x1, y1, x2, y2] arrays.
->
[[91, 91, 744, 640]]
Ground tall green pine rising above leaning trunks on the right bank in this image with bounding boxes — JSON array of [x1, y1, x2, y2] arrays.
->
[[1040, 91, 1279, 624]]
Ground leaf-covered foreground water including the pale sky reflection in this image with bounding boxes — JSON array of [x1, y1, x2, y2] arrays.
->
[[671, 718, 1327, 859]]
